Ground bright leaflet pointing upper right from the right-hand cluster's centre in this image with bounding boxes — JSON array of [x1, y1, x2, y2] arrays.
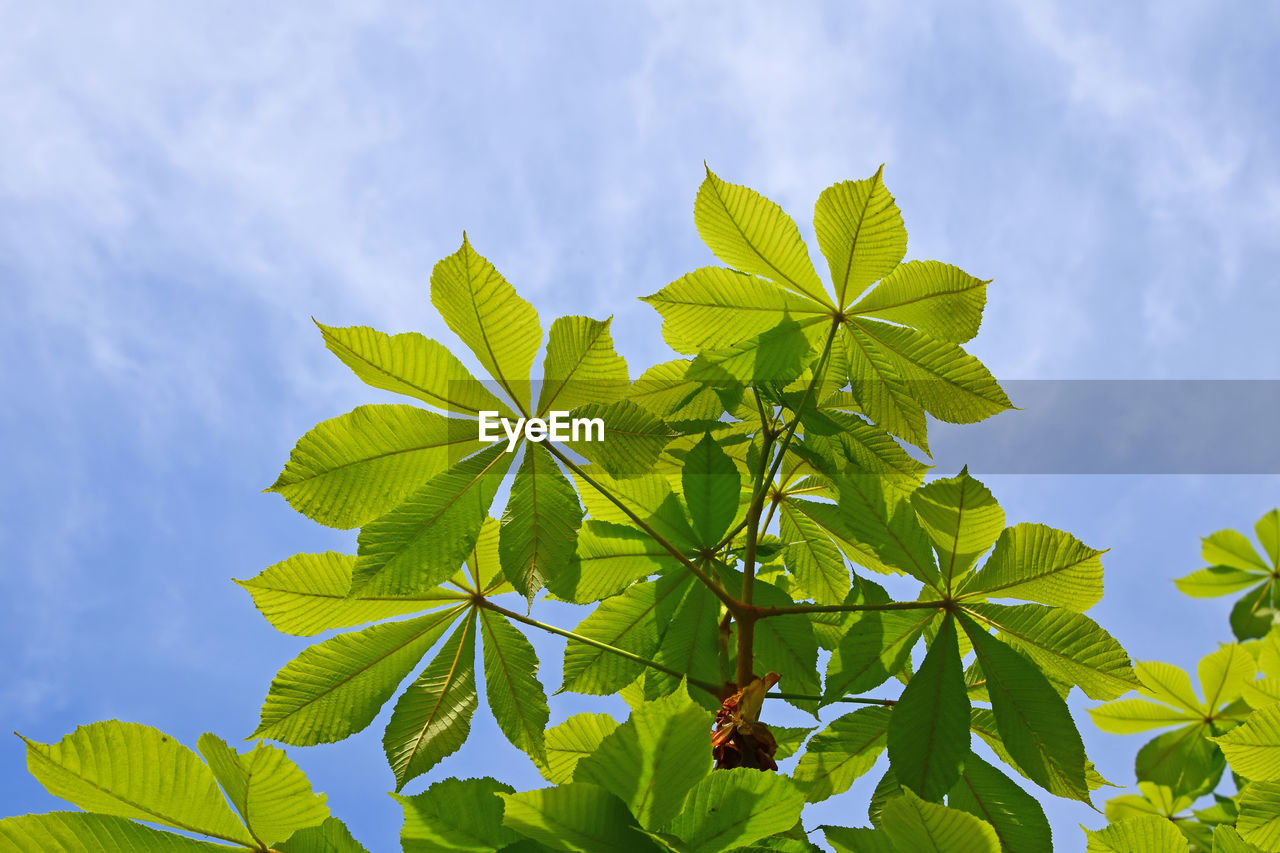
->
[[959, 524, 1106, 612]]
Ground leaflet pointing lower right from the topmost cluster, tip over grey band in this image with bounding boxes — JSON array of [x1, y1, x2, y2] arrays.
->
[[846, 319, 1014, 422]]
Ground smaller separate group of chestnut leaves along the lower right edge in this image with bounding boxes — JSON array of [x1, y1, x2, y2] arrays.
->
[[1089, 510, 1280, 853]]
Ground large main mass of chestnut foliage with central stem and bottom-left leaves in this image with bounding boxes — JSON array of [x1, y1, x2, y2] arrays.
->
[[0, 172, 1157, 853]]
